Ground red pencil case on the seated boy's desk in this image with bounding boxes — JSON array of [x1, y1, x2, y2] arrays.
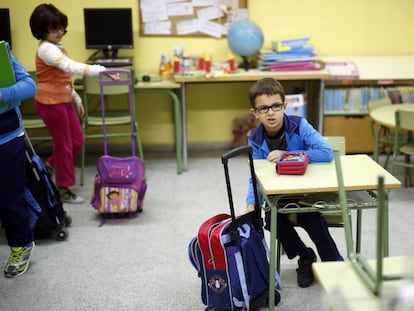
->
[[276, 151, 309, 175]]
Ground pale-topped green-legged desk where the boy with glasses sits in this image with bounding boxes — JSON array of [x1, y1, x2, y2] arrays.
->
[[254, 154, 401, 310]]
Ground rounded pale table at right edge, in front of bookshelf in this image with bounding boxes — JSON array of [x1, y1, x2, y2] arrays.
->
[[370, 104, 414, 165]]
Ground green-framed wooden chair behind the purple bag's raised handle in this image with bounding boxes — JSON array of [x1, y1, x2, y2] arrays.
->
[[80, 69, 144, 185]]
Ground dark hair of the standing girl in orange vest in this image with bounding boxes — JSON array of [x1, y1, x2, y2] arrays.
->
[[30, 3, 68, 40]]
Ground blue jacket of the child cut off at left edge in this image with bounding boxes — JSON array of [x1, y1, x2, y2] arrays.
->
[[0, 45, 36, 145]]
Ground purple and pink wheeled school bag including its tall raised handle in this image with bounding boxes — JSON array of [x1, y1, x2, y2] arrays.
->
[[91, 69, 147, 214]]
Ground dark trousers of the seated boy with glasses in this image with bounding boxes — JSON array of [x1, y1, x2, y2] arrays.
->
[[266, 212, 343, 261]]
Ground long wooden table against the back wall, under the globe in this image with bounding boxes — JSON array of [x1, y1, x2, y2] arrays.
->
[[174, 69, 329, 170]]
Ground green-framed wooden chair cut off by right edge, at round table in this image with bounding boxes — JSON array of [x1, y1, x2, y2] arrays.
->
[[390, 110, 414, 187]]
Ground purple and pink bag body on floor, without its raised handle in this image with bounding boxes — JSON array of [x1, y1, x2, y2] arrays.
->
[[91, 155, 147, 213]]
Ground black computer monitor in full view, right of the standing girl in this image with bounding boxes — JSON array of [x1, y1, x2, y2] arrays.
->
[[83, 8, 134, 58]]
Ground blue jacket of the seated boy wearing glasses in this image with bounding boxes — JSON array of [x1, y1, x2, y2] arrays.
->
[[246, 114, 333, 204]]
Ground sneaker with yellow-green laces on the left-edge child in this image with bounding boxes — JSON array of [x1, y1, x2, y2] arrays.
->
[[4, 242, 35, 278]]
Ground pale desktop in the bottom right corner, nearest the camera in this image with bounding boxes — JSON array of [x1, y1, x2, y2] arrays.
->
[[312, 256, 414, 311]]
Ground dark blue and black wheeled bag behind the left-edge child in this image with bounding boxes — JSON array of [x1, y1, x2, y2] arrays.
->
[[23, 133, 72, 241]]
